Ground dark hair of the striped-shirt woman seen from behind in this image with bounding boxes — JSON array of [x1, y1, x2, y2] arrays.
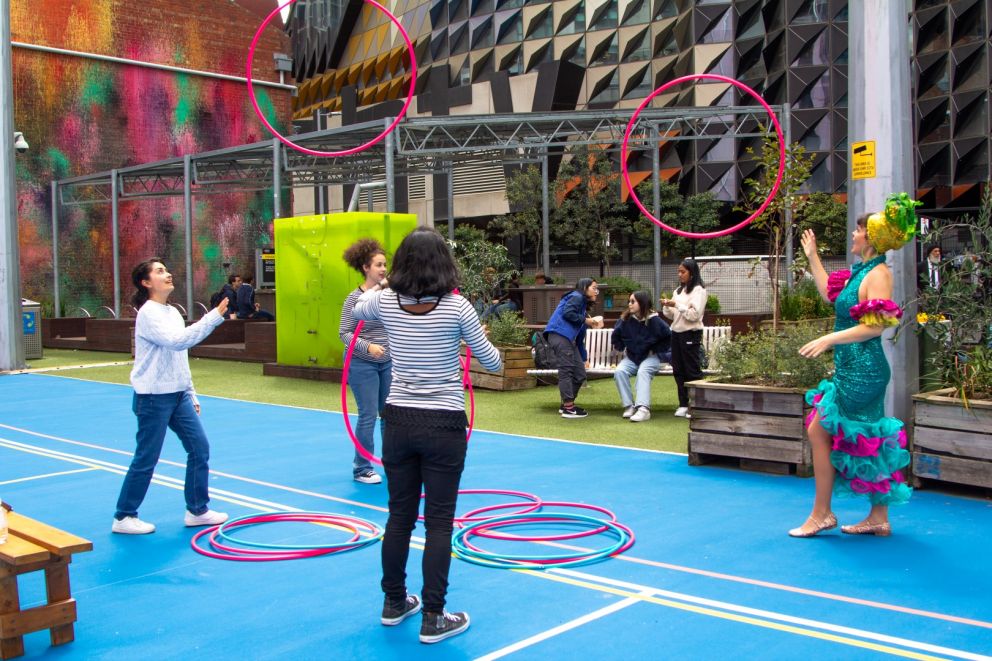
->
[[388, 226, 458, 298]]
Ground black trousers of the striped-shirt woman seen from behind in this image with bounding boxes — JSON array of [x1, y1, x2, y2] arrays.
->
[[382, 421, 468, 612]]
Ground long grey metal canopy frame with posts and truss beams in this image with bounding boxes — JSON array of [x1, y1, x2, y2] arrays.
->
[[52, 105, 790, 316]]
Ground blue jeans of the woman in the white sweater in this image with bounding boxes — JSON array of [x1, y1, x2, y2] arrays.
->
[[114, 392, 210, 519]]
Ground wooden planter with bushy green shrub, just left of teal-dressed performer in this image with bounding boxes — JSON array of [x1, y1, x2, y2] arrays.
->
[[687, 326, 832, 477]]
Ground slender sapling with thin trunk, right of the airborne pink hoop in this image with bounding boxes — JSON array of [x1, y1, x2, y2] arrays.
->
[[735, 127, 814, 330]]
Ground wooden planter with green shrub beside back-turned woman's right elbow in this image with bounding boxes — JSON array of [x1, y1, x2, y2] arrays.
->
[[463, 312, 537, 390]]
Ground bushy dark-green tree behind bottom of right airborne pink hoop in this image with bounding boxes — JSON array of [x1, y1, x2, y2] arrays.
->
[[634, 180, 730, 259]]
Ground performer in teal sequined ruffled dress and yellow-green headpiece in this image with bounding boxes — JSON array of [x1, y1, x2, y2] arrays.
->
[[789, 193, 919, 537]]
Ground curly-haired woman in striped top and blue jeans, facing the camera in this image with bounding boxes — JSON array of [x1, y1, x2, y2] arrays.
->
[[338, 239, 393, 484]]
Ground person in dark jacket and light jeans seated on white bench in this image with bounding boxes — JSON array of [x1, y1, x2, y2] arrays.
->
[[610, 291, 672, 422]]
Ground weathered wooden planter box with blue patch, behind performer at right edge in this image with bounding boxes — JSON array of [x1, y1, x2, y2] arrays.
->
[[913, 388, 992, 489]]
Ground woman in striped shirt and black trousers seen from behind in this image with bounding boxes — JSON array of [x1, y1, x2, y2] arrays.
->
[[354, 227, 501, 643]]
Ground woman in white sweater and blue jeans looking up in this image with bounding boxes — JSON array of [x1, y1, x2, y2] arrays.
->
[[112, 258, 228, 535]]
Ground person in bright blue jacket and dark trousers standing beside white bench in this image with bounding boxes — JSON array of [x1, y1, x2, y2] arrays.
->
[[544, 278, 603, 419]]
